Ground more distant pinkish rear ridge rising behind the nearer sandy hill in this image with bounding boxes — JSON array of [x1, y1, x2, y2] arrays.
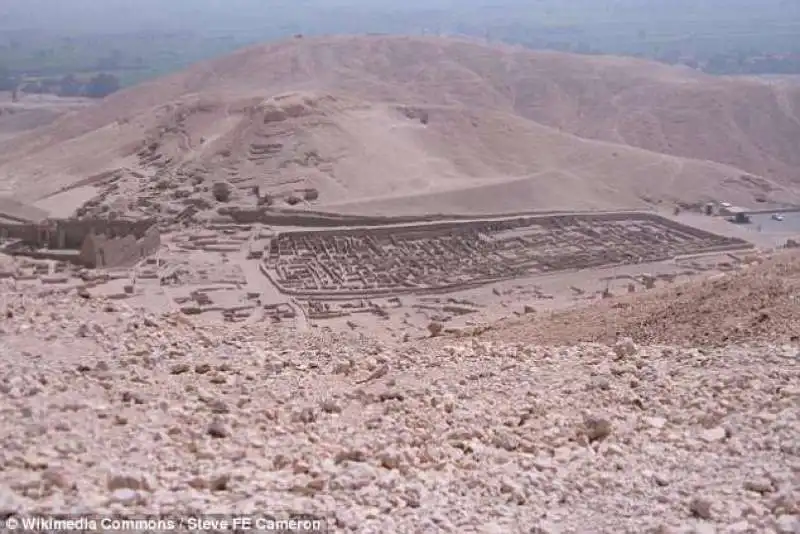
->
[[144, 36, 800, 186]]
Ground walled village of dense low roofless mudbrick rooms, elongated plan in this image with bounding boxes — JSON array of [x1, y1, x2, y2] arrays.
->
[[263, 213, 750, 299]]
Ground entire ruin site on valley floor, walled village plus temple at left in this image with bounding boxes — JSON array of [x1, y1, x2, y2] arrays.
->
[[0, 199, 764, 332]]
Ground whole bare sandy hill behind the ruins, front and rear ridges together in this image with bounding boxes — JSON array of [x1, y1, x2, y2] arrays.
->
[[0, 36, 800, 218]]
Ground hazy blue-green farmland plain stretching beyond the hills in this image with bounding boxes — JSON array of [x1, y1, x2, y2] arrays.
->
[[0, 0, 800, 96]]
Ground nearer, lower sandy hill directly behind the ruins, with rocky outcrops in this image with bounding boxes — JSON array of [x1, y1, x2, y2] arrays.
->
[[6, 88, 800, 213]]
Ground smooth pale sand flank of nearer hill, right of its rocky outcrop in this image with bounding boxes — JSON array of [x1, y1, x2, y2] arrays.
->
[[324, 107, 800, 214]]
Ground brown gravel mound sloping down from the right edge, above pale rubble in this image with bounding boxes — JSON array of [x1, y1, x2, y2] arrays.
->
[[486, 251, 800, 346]]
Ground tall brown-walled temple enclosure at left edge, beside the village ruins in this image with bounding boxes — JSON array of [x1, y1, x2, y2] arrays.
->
[[0, 219, 161, 268]]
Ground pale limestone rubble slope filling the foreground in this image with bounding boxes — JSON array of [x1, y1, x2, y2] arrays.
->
[[0, 282, 800, 534]]
